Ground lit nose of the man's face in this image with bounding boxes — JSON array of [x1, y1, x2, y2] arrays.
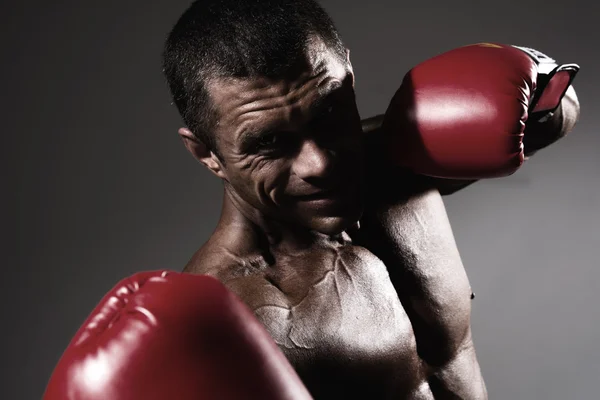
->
[[293, 140, 335, 180]]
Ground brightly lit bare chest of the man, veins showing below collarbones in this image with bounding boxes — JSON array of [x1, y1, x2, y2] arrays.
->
[[255, 246, 412, 353]]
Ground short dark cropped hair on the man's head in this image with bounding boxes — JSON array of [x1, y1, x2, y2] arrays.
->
[[163, 0, 346, 155]]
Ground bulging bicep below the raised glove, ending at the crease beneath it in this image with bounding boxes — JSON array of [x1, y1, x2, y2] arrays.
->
[[359, 189, 472, 365]]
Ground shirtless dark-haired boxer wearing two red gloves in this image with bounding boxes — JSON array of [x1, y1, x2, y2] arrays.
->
[[44, 0, 579, 399]]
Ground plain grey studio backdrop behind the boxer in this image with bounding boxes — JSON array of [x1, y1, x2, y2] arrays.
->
[[5, 0, 600, 399]]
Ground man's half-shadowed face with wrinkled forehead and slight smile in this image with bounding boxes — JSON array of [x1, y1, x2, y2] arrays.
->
[[209, 42, 363, 234]]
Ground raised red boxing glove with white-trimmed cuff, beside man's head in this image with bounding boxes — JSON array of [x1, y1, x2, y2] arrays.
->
[[382, 43, 579, 179]]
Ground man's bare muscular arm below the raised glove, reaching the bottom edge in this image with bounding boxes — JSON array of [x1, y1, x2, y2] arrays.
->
[[352, 180, 486, 399]]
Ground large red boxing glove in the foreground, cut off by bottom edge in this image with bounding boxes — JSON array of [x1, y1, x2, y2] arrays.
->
[[44, 271, 310, 400]]
